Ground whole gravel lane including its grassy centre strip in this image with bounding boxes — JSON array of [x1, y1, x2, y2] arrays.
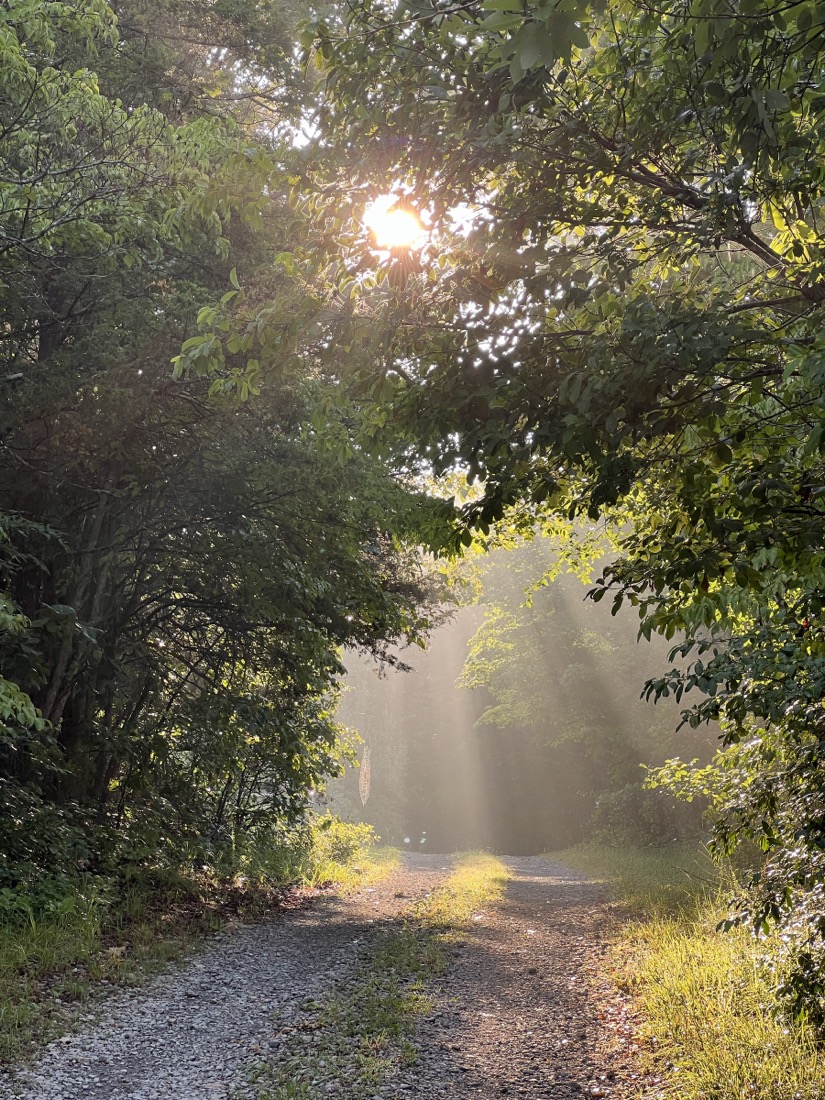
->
[[0, 854, 658, 1100]]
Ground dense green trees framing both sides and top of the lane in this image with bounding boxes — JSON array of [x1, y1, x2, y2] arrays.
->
[[0, 0, 825, 1019]]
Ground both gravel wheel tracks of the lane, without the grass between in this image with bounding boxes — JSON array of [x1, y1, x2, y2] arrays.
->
[[0, 855, 646, 1100]]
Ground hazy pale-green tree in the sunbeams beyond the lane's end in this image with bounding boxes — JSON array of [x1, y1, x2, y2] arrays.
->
[[459, 538, 715, 843]]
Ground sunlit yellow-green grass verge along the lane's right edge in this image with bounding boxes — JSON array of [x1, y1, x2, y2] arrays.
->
[[554, 845, 825, 1100]]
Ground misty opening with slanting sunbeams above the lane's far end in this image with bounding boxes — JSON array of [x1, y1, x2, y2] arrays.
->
[[327, 542, 715, 854]]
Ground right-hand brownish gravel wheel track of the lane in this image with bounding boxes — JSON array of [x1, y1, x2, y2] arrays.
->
[[404, 857, 652, 1100]]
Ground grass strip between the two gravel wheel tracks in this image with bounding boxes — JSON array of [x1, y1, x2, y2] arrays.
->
[[255, 853, 508, 1100]]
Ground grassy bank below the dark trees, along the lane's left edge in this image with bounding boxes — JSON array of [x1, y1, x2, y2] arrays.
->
[[0, 824, 399, 1064]]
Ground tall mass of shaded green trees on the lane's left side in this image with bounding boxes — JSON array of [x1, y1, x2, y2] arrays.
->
[[0, 0, 446, 919]]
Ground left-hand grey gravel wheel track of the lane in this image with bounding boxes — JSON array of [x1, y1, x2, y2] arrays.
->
[[0, 857, 449, 1100]]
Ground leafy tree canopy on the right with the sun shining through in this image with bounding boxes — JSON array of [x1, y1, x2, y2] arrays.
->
[[237, 0, 825, 1004]]
